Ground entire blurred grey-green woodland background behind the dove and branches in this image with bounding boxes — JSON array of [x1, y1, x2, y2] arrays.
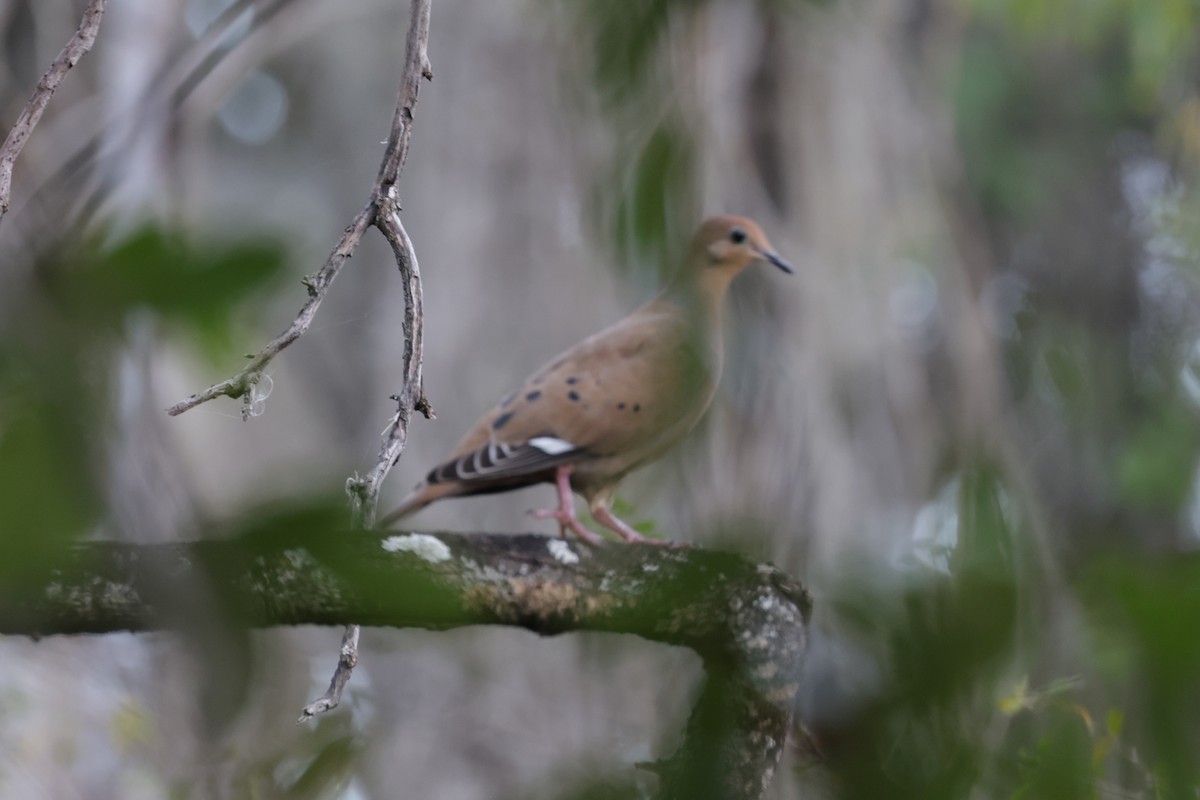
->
[[0, 0, 1200, 800]]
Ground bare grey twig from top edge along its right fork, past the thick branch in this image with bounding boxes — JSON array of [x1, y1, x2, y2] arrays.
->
[[292, 0, 433, 722]]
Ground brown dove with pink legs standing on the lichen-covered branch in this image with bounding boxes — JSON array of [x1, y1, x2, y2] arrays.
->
[[379, 215, 794, 545]]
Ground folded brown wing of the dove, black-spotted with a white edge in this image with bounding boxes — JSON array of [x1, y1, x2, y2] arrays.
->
[[426, 301, 712, 493]]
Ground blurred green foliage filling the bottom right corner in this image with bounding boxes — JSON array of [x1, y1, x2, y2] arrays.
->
[[816, 469, 1200, 800]]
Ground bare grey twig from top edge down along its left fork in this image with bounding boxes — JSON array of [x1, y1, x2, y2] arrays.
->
[[167, 0, 433, 420]]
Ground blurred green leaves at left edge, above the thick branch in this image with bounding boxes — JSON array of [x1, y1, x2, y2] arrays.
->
[[0, 221, 283, 581]]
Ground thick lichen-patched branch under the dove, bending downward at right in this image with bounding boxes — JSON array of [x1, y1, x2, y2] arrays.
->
[[9, 532, 811, 800]]
